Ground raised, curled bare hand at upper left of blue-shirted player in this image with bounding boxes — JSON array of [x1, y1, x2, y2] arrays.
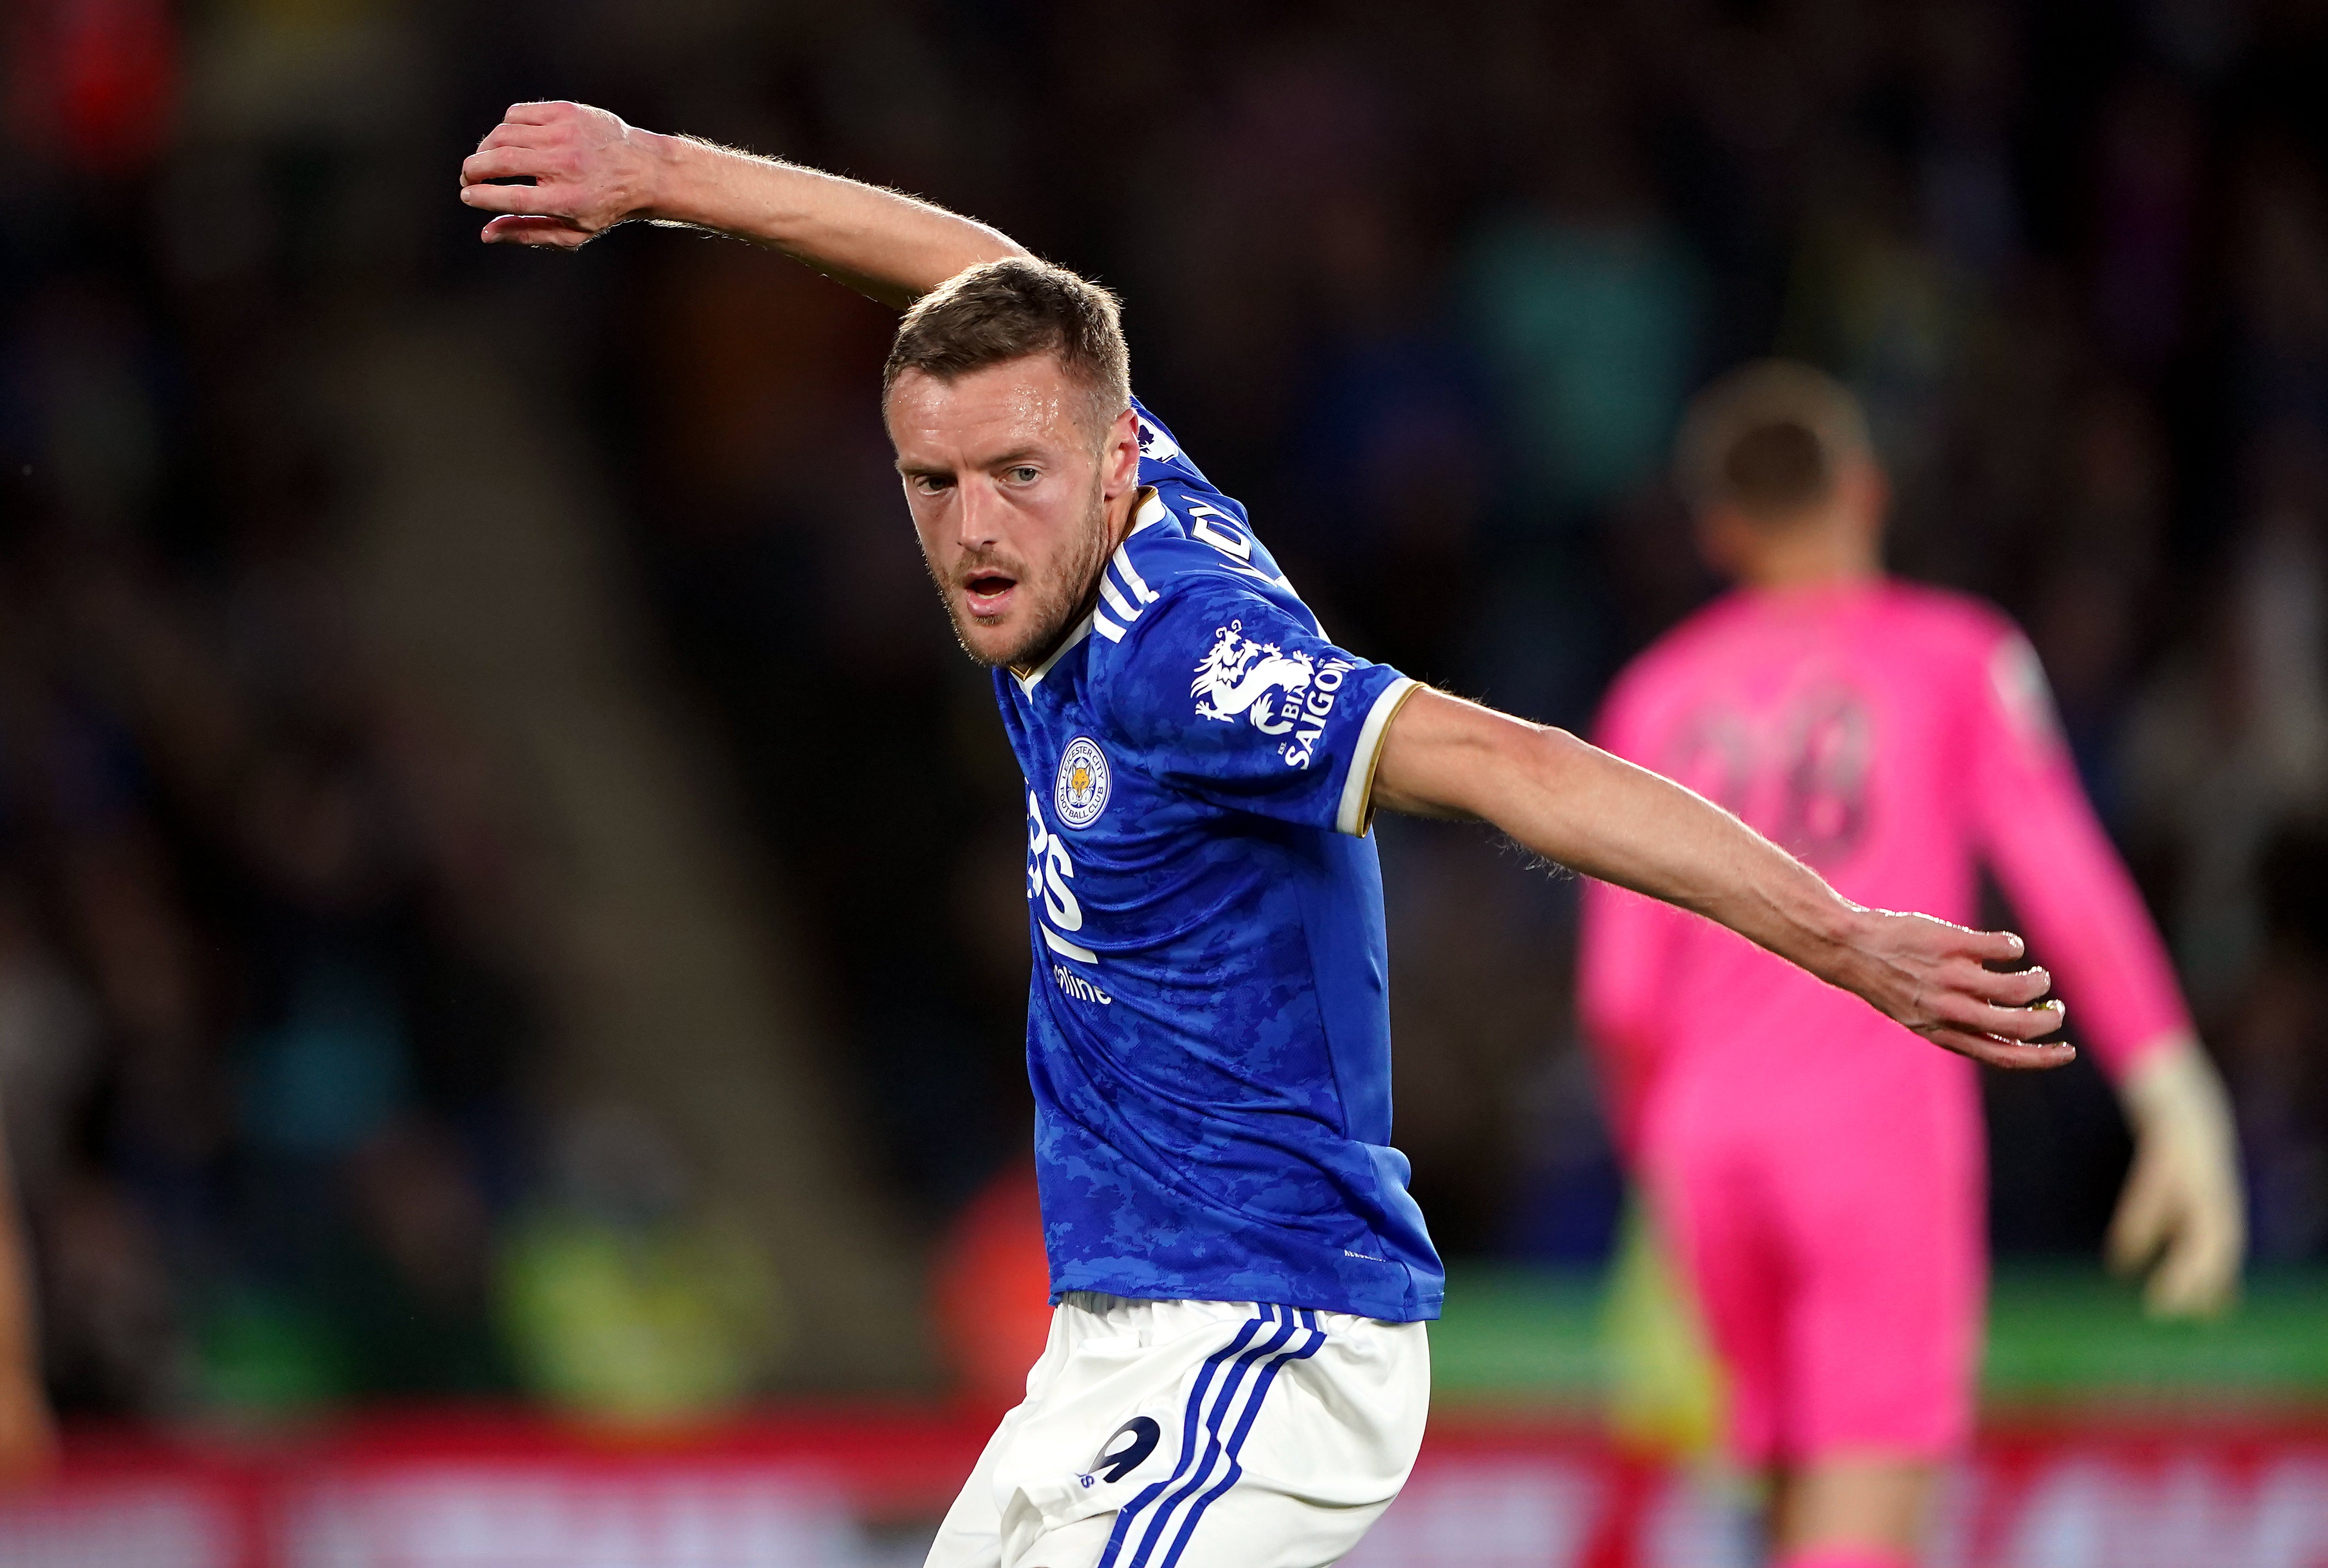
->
[[461, 102, 664, 249]]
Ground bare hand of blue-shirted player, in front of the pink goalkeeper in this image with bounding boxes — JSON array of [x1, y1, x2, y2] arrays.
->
[[1846, 909, 2076, 1068]]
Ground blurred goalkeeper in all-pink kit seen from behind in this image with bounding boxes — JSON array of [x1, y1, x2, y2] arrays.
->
[[1581, 363, 2242, 1568]]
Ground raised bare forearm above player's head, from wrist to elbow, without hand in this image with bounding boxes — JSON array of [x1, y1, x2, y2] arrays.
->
[[638, 133, 1027, 305]]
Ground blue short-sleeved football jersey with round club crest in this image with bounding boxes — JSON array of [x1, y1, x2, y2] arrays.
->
[[994, 405, 1446, 1321]]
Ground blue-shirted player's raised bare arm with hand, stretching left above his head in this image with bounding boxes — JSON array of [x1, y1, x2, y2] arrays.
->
[[461, 102, 1027, 307]]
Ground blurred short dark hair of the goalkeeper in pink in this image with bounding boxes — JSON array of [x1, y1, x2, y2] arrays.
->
[[1674, 358, 1874, 521]]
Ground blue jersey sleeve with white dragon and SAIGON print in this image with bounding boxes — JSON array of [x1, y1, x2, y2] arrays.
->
[[1099, 584, 1415, 835]]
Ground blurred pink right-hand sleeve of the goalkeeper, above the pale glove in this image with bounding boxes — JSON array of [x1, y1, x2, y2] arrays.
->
[[1969, 631, 2190, 1077]]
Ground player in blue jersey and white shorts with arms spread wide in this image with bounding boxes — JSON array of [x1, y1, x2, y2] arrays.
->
[[461, 102, 2072, 1568]]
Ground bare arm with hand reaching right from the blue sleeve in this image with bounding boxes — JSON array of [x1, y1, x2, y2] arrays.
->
[[1374, 689, 2076, 1068]]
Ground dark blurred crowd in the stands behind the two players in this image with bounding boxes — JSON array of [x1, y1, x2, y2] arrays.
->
[[0, 0, 2328, 1412]]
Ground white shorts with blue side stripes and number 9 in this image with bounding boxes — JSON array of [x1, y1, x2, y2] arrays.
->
[[926, 1291, 1432, 1568]]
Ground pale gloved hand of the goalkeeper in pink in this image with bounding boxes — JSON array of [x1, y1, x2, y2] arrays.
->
[[2109, 1035, 2247, 1317]]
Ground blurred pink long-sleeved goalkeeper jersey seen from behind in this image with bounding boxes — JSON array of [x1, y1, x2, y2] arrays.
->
[[1578, 582, 2189, 1152]]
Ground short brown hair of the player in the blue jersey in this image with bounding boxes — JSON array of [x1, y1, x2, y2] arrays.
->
[[880, 256, 1131, 431]]
